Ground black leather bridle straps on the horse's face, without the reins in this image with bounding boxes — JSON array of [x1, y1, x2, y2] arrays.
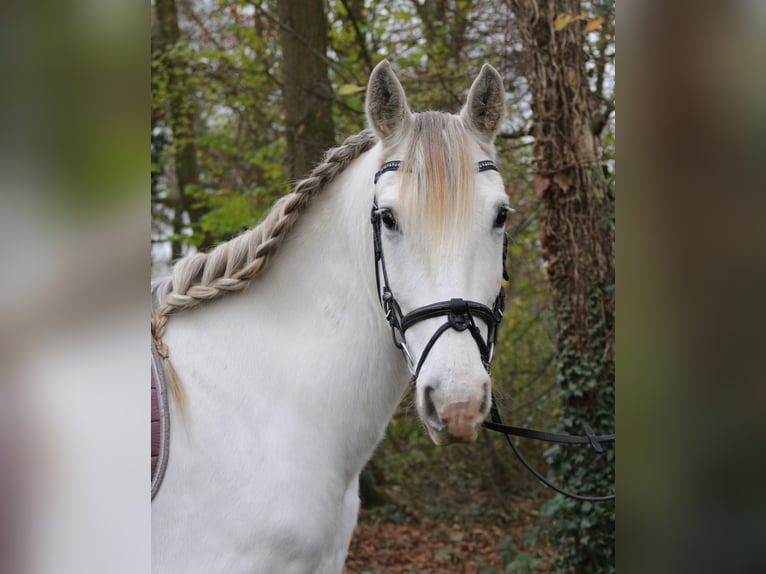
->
[[370, 160, 508, 381]]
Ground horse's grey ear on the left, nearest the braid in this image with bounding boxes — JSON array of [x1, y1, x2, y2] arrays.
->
[[365, 60, 412, 141]]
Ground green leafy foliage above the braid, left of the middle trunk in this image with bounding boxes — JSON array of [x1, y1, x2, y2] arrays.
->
[[152, 2, 288, 252]]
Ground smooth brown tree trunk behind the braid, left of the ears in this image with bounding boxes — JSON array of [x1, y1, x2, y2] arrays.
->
[[279, 0, 335, 179]]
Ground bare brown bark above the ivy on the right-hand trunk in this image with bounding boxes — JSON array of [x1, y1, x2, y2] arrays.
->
[[518, 4, 614, 330]]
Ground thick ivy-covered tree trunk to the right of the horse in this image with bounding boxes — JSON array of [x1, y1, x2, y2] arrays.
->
[[511, 0, 614, 573]]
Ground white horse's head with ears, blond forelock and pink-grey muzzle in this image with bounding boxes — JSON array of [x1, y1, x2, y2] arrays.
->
[[366, 61, 509, 445]]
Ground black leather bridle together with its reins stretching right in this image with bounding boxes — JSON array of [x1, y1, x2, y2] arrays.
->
[[370, 160, 615, 502]]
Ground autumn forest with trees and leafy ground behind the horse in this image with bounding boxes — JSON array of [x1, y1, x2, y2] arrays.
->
[[151, 0, 615, 573]]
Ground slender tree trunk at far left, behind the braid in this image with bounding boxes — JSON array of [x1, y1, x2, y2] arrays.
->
[[155, 0, 212, 260]]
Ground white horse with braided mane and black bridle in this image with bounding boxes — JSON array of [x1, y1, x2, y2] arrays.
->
[[152, 61, 509, 574]]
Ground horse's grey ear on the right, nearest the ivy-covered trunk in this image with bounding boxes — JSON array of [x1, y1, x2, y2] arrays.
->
[[460, 64, 505, 143]]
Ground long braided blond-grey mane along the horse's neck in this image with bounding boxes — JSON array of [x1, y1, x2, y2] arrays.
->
[[151, 129, 378, 413]]
